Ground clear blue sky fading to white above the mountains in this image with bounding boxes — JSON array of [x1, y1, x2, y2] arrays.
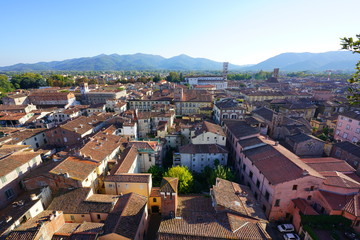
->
[[0, 0, 360, 66]]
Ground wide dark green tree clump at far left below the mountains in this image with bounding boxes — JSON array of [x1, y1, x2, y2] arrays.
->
[[11, 73, 47, 89]]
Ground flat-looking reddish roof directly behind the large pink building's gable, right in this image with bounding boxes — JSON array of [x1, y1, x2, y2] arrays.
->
[[301, 157, 355, 172]]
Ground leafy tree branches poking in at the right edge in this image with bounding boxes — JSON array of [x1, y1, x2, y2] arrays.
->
[[341, 34, 360, 104]]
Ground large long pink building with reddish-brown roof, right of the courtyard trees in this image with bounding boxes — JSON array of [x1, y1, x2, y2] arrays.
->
[[235, 137, 324, 221]]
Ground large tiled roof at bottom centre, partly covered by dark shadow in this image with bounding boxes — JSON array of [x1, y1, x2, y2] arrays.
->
[[158, 196, 271, 240]]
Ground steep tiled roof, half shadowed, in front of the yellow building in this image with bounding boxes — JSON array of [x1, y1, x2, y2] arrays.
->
[[104, 193, 148, 239]]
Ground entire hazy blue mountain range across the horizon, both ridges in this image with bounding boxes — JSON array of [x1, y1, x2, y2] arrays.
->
[[0, 51, 360, 72]]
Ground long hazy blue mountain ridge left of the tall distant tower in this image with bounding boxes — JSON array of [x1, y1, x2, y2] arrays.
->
[[0, 53, 242, 72]]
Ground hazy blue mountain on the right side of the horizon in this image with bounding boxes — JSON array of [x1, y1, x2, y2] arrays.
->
[[246, 51, 360, 71]]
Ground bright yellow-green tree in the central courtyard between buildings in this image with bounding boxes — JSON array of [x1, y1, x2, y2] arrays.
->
[[164, 166, 194, 193]]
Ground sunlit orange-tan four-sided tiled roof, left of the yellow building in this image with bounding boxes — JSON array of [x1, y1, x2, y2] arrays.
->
[[50, 157, 99, 181]]
